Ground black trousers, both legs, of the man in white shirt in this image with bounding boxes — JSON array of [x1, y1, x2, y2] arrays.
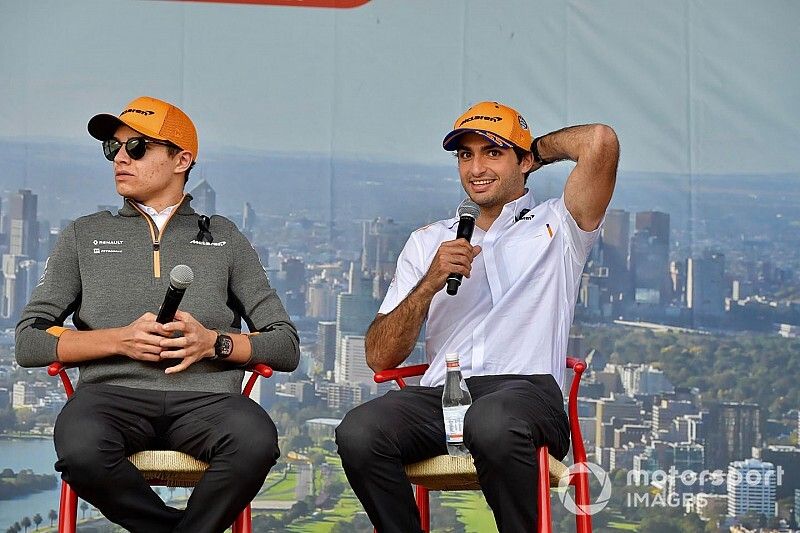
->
[[336, 375, 569, 533]]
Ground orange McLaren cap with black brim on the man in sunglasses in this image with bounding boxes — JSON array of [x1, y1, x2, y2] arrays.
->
[[88, 96, 197, 161]]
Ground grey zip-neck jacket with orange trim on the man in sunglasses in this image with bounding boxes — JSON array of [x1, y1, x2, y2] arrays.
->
[[16, 194, 299, 393]]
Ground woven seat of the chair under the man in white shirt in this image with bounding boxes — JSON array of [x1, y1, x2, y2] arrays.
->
[[405, 455, 569, 490]]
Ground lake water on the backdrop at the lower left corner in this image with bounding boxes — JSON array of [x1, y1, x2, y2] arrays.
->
[[0, 439, 61, 531]]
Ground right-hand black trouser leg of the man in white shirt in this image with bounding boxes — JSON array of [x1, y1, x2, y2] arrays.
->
[[464, 375, 569, 533]]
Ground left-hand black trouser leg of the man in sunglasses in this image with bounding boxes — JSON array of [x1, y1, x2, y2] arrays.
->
[[54, 385, 182, 533]]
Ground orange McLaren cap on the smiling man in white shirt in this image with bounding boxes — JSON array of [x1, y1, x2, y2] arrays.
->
[[442, 102, 533, 152]]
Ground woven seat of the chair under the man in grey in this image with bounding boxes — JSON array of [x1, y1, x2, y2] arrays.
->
[[128, 450, 208, 487]]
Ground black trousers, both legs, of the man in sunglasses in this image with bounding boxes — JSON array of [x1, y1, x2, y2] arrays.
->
[[54, 384, 280, 533]]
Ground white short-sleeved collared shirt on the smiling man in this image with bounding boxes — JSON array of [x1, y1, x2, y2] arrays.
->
[[379, 191, 602, 386]]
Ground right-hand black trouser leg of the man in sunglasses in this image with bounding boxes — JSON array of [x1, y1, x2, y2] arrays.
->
[[167, 392, 280, 533]]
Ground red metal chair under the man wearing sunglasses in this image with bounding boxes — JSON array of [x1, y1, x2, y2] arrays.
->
[[47, 363, 272, 533]]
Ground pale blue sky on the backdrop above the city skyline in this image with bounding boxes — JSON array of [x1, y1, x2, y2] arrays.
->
[[0, 0, 800, 174]]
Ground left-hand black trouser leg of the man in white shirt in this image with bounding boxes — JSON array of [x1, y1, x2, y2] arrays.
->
[[336, 387, 447, 533]]
